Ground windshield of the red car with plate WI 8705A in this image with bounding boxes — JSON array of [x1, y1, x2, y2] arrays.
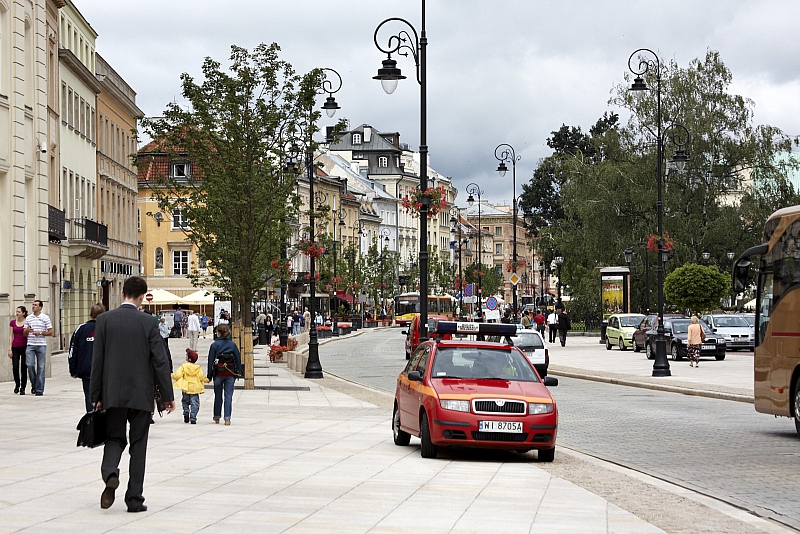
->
[[431, 347, 539, 382]]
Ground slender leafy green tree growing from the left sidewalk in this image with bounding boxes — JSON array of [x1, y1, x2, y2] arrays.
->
[[142, 44, 322, 382]]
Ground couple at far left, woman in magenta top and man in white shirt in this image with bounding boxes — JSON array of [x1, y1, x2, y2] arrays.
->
[[8, 300, 53, 396]]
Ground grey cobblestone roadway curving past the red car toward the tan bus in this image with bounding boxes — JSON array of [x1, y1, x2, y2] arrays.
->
[[320, 328, 800, 529]]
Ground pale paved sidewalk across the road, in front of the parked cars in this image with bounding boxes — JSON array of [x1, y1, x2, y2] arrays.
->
[[548, 336, 753, 403]]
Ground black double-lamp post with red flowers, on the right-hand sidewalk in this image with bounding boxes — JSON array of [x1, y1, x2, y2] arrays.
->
[[628, 48, 689, 376]]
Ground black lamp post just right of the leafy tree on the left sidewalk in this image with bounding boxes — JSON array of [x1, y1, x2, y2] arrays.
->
[[301, 68, 342, 378]]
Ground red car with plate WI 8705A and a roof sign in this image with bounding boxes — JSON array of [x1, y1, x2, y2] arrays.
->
[[392, 321, 558, 462]]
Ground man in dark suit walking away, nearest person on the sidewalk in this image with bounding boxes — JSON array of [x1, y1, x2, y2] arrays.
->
[[90, 276, 175, 512]]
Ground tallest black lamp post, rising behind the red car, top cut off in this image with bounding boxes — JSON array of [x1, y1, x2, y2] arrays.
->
[[373, 0, 431, 341]]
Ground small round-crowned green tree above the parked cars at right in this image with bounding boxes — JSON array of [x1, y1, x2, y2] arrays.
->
[[664, 263, 731, 312]]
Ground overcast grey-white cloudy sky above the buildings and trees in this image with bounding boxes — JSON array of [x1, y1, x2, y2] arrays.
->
[[73, 0, 800, 204]]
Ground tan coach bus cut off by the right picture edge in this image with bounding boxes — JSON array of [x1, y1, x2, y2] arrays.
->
[[732, 206, 800, 434]]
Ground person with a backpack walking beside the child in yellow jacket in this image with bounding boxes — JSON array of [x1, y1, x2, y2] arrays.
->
[[208, 324, 242, 426]]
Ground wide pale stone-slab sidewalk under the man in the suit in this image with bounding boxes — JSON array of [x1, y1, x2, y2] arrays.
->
[[0, 339, 663, 534]]
